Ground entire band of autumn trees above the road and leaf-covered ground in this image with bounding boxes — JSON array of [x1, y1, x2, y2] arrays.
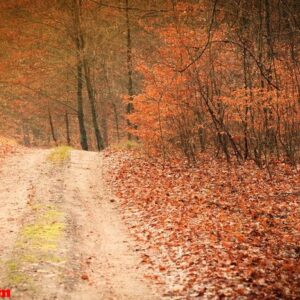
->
[[0, 0, 300, 165]]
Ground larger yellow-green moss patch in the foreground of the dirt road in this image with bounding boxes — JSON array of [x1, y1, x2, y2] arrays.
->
[[5, 205, 65, 292]]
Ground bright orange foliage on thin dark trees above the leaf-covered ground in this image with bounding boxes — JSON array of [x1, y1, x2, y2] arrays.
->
[[129, 2, 300, 166]]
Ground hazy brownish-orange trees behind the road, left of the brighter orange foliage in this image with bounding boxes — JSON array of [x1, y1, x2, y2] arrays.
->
[[0, 0, 162, 150]]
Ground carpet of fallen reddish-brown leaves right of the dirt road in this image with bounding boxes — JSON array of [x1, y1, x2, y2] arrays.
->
[[104, 150, 300, 299]]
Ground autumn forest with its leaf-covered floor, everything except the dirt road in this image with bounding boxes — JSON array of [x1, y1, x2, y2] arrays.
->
[[0, 0, 300, 299]]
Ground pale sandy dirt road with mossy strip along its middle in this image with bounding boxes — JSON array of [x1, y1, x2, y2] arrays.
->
[[0, 150, 158, 300]]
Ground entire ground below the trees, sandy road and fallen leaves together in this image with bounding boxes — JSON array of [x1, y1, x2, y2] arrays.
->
[[0, 143, 300, 300]]
